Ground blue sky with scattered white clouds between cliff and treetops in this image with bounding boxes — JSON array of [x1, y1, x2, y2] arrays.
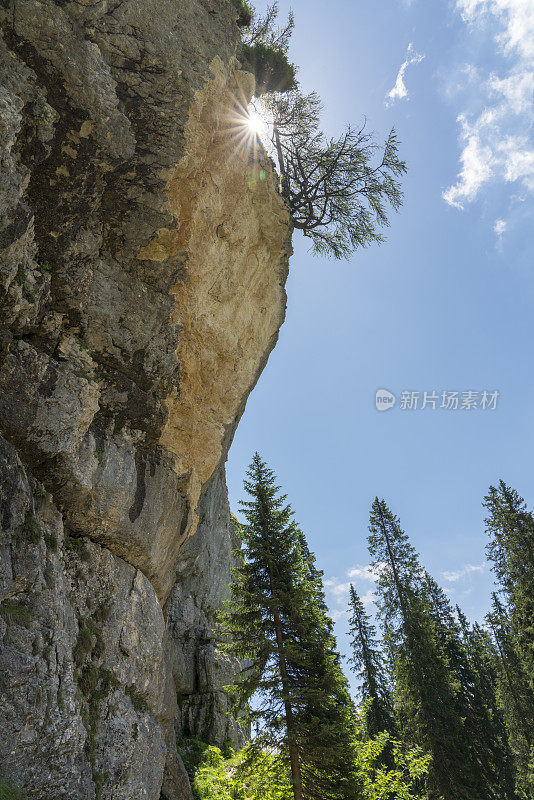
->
[[228, 0, 534, 692]]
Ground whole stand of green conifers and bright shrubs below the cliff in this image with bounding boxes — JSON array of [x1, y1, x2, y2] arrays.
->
[[219, 460, 534, 800]]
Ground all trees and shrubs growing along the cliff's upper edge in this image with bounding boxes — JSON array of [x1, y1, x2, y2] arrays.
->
[[233, 0, 406, 258]]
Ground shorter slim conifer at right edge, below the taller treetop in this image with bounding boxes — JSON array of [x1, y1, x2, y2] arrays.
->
[[486, 593, 534, 798]]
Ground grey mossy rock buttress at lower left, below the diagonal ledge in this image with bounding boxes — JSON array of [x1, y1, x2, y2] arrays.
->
[[0, 439, 171, 800]]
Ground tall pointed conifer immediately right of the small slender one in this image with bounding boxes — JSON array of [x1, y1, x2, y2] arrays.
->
[[369, 498, 486, 800]]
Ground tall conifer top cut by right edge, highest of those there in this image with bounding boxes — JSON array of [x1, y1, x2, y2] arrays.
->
[[484, 481, 534, 689]]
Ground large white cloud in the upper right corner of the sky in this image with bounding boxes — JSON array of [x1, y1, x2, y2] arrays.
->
[[443, 0, 534, 209]]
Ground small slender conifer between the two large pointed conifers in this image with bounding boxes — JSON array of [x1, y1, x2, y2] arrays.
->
[[349, 584, 397, 738]]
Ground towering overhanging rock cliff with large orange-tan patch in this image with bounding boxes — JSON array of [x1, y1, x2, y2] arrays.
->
[[0, 0, 289, 800]]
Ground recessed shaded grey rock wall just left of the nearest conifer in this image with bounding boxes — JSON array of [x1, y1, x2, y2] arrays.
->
[[166, 469, 246, 747]]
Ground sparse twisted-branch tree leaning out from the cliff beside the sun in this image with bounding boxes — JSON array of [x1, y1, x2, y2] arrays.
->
[[274, 90, 406, 258]]
